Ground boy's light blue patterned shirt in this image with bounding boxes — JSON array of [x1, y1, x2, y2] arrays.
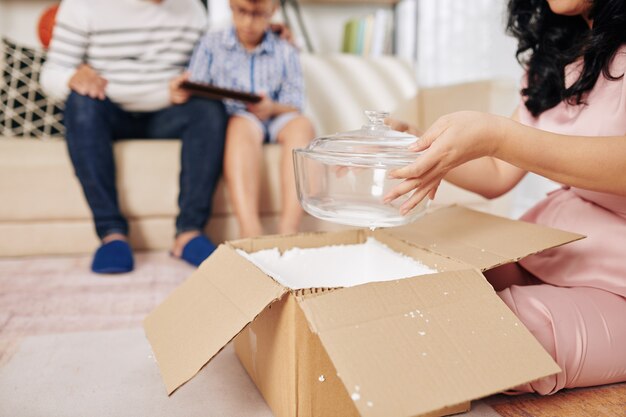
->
[[189, 27, 304, 115]]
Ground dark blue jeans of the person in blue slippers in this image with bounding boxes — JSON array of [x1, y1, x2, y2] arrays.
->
[[64, 92, 227, 239]]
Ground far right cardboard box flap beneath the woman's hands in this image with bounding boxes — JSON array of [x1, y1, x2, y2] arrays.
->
[[381, 206, 584, 271]]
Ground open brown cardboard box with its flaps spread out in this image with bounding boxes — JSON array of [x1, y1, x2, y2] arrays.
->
[[144, 206, 582, 417]]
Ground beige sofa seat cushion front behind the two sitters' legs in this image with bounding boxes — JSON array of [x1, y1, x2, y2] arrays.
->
[[0, 137, 281, 221]]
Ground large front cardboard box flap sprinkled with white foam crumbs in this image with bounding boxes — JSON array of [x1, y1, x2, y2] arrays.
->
[[298, 269, 560, 416]]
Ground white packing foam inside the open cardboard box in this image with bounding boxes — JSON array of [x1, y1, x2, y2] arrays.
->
[[237, 237, 437, 290]]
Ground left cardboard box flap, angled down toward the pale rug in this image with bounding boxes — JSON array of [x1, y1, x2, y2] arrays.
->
[[144, 245, 287, 394]]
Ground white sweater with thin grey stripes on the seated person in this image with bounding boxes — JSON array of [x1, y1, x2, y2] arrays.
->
[[40, 0, 207, 112]]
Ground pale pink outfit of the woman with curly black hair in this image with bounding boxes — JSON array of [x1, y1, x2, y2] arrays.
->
[[489, 46, 626, 394]]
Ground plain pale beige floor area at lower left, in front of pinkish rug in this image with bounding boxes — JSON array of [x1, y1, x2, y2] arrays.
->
[[0, 329, 272, 417]]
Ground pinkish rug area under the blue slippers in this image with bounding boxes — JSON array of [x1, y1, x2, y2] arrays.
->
[[0, 252, 194, 365]]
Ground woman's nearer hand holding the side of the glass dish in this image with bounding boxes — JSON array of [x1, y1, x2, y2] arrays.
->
[[384, 111, 508, 214]]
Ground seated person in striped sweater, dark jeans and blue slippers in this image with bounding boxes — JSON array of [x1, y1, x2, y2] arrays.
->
[[40, 0, 227, 273]]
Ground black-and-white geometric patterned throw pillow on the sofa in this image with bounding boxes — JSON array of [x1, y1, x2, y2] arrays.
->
[[0, 38, 65, 138]]
